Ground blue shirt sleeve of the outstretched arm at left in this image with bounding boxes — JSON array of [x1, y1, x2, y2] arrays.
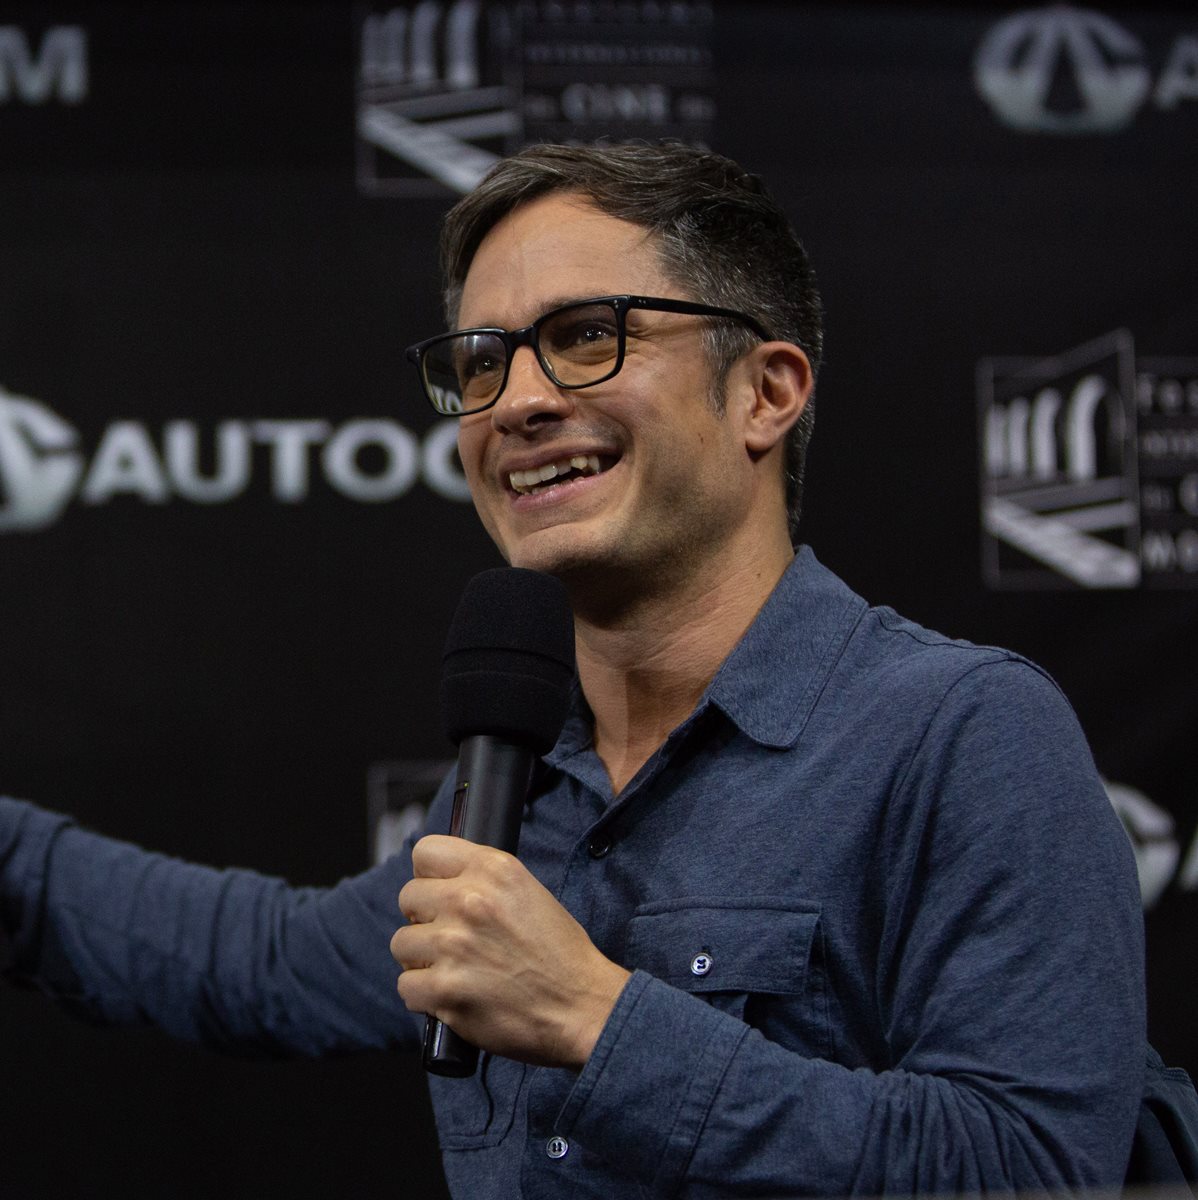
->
[[0, 798, 419, 1055]]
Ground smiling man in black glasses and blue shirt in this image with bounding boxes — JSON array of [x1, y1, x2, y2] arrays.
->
[[0, 145, 1145, 1200]]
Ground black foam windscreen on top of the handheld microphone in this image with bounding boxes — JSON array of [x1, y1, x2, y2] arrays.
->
[[441, 566, 574, 754]]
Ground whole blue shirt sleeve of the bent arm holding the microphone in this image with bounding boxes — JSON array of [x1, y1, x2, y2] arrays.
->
[[557, 660, 1145, 1200]]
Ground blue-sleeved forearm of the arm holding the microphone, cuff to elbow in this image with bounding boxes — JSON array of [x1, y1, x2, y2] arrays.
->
[[552, 972, 1143, 1200]]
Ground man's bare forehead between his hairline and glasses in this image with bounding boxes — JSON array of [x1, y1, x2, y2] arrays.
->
[[457, 194, 678, 329]]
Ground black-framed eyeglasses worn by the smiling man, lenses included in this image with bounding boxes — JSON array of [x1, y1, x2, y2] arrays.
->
[[407, 296, 772, 416]]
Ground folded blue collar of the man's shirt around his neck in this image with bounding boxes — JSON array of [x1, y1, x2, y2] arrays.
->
[[545, 546, 867, 767]]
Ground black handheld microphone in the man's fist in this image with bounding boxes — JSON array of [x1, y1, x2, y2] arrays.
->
[[424, 566, 574, 1078]]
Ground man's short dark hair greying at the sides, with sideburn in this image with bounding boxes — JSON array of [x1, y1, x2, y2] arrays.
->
[[441, 142, 823, 538]]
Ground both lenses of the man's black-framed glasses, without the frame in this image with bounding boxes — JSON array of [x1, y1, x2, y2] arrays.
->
[[421, 302, 619, 414]]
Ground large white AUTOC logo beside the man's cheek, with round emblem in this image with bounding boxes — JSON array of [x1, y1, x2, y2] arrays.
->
[[0, 389, 469, 533]]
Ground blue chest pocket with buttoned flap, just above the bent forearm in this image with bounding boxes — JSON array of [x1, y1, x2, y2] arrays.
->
[[624, 896, 832, 1057]]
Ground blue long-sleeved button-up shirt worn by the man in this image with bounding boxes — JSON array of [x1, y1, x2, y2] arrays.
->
[[0, 550, 1145, 1200]]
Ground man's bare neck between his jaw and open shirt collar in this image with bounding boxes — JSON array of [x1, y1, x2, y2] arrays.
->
[[571, 541, 793, 794]]
